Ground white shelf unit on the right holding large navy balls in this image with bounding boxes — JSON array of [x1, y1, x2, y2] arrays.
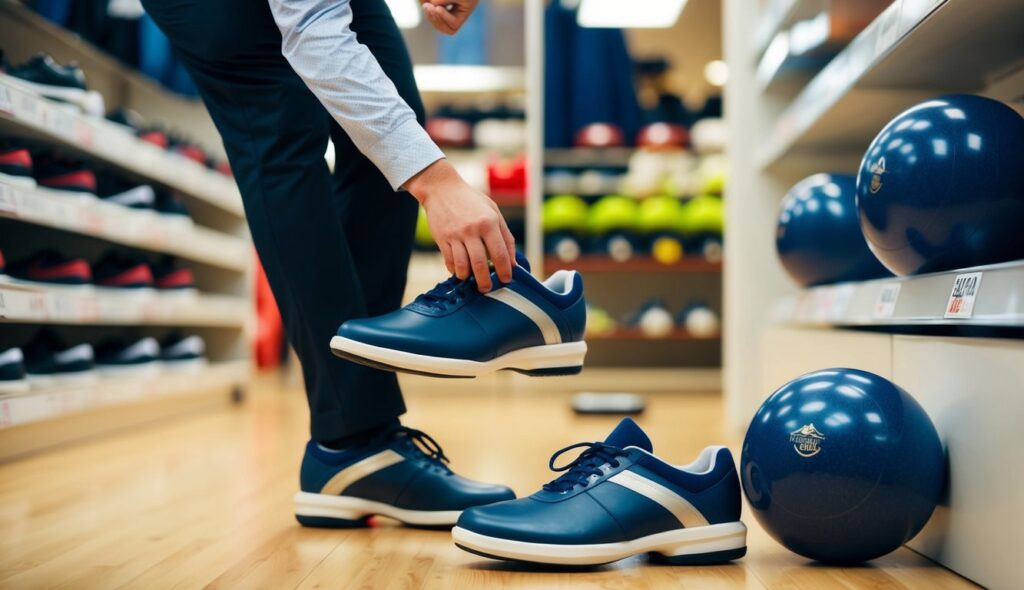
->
[[724, 0, 1024, 587]]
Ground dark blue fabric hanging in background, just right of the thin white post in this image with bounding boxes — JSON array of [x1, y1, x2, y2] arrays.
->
[[544, 0, 643, 148]]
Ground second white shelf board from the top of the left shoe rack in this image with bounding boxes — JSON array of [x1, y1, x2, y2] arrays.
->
[[0, 180, 251, 271]]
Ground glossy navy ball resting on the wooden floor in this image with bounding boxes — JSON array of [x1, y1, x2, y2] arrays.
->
[[740, 369, 945, 563]]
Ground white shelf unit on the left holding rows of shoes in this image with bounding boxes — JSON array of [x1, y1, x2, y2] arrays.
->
[[0, 2, 255, 450]]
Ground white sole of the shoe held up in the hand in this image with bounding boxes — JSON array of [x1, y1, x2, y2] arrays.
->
[[331, 336, 587, 377]]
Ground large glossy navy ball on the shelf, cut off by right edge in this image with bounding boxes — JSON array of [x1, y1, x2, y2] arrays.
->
[[857, 94, 1024, 275]]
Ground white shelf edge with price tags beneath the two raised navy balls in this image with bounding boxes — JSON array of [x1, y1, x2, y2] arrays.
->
[[776, 260, 1024, 327]]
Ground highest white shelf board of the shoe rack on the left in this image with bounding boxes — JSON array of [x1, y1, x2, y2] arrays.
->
[[0, 74, 244, 216]]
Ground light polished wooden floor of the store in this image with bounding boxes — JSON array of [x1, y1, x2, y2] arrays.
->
[[0, 374, 971, 590]]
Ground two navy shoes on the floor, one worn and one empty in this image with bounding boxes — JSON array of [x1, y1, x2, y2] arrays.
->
[[295, 418, 746, 565]]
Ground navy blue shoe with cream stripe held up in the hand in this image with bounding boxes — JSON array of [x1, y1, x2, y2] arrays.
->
[[331, 254, 587, 377]]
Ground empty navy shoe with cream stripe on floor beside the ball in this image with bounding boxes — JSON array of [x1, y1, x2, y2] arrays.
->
[[452, 418, 746, 565]]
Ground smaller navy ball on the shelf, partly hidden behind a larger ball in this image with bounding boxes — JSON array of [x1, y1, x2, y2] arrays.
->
[[775, 174, 891, 287]]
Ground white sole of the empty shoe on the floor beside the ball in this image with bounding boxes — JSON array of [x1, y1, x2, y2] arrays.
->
[[452, 521, 746, 565]]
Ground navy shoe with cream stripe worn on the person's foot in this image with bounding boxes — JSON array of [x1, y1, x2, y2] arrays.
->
[[295, 426, 515, 528]]
